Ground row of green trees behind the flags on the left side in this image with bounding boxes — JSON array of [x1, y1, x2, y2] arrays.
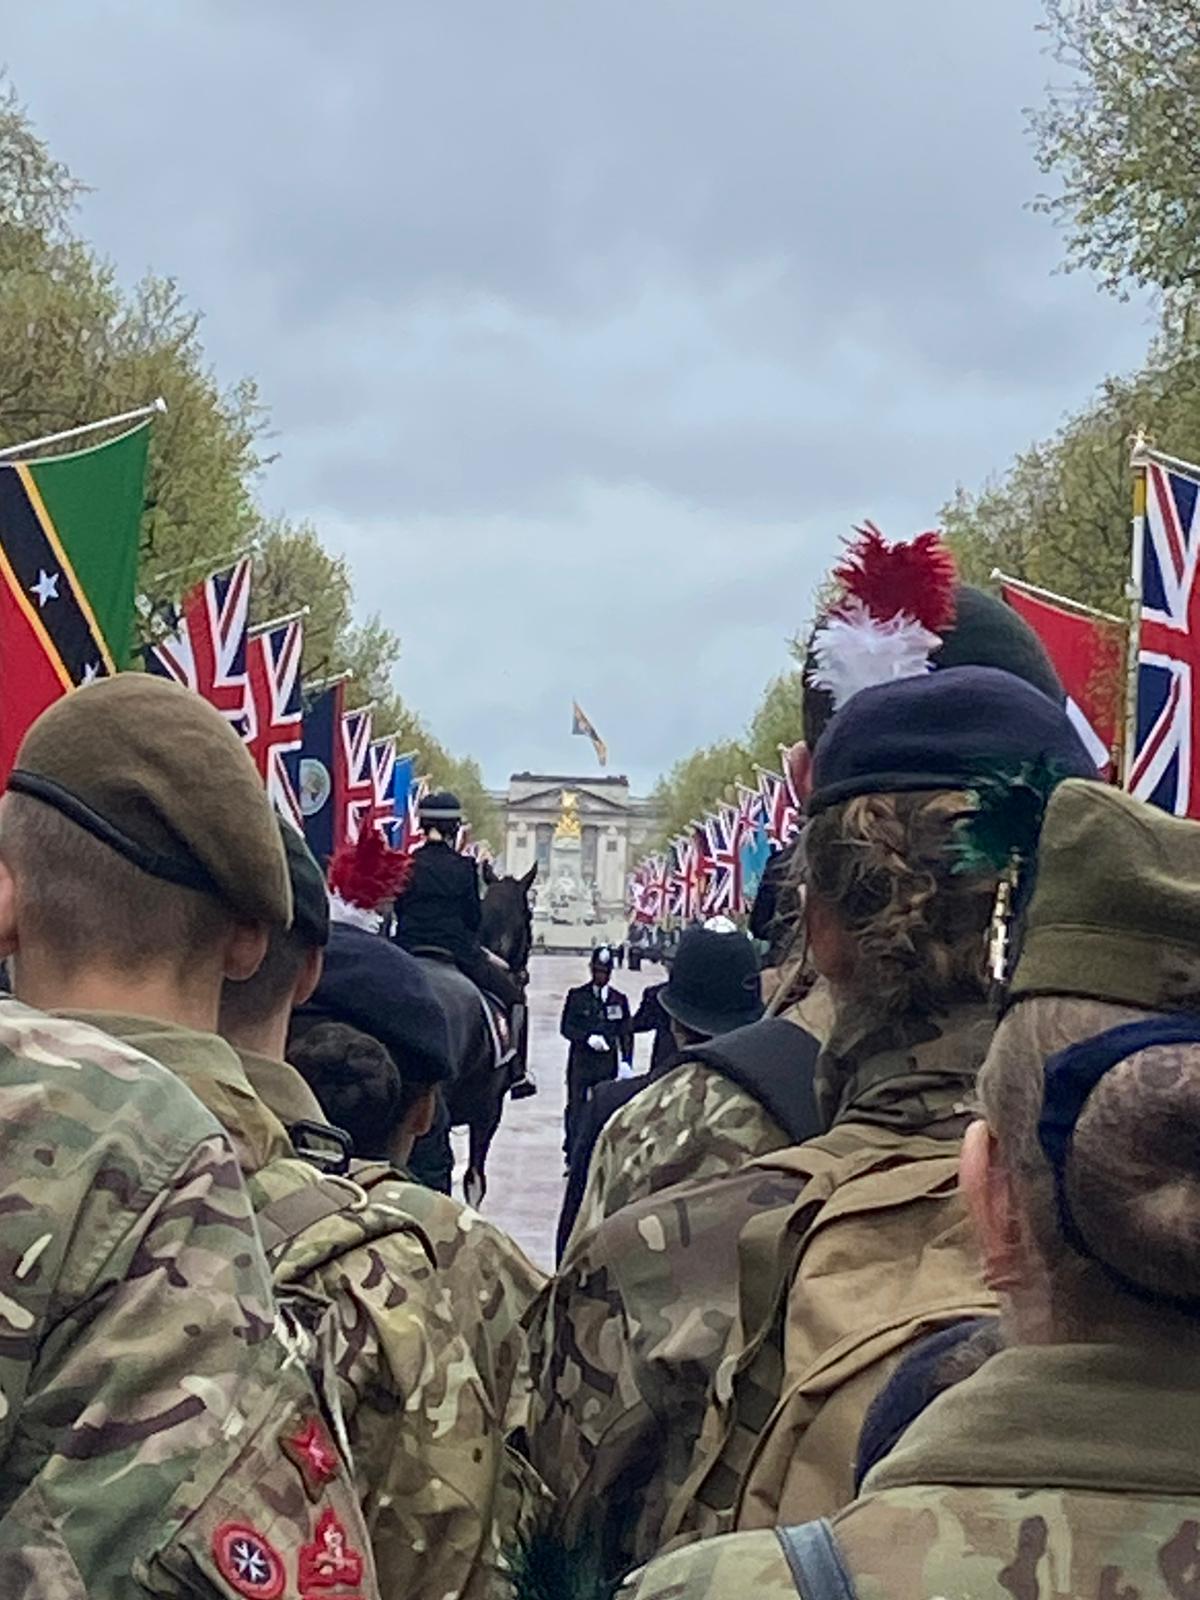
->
[[0, 82, 498, 842]]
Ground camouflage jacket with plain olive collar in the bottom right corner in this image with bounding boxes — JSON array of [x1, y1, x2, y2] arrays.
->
[[622, 1341, 1200, 1600]]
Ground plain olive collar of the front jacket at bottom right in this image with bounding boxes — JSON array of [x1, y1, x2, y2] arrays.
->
[[862, 1334, 1200, 1496]]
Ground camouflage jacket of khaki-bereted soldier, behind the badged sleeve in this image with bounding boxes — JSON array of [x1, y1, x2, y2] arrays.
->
[[64, 1013, 524, 1600]]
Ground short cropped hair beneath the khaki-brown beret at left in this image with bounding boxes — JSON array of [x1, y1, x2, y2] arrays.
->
[[0, 794, 235, 973]]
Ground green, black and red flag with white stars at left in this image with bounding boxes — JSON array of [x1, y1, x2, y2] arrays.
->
[[0, 422, 150, 781]]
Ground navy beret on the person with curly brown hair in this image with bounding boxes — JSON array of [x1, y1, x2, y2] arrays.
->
[[808, 667, 1096, 816]]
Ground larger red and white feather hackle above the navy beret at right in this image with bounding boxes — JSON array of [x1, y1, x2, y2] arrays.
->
[[810, 522, 957, 709]]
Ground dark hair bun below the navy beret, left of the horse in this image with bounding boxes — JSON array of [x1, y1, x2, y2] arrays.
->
[[288, 1022, 429, 1160]]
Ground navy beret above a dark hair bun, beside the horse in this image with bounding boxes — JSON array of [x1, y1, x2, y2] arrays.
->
[[293, 923, 453, 1085]]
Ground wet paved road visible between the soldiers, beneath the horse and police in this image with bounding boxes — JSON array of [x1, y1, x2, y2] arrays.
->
[[454, 955, 664, 1267]]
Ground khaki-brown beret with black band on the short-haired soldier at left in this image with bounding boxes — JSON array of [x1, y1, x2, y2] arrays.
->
[[8, 672, 291, 928]]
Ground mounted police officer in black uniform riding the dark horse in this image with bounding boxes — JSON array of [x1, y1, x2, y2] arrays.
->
[[395, 790, 522, 1010]]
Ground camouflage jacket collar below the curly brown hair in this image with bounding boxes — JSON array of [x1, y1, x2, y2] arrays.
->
[[816, 1002, 995, 1138]]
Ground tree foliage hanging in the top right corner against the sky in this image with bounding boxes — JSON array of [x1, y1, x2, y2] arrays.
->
[[1030, 0, 1200, 299]]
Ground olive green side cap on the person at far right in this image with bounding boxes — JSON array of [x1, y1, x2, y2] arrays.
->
[[1008, 778, 1200, 1011]]
